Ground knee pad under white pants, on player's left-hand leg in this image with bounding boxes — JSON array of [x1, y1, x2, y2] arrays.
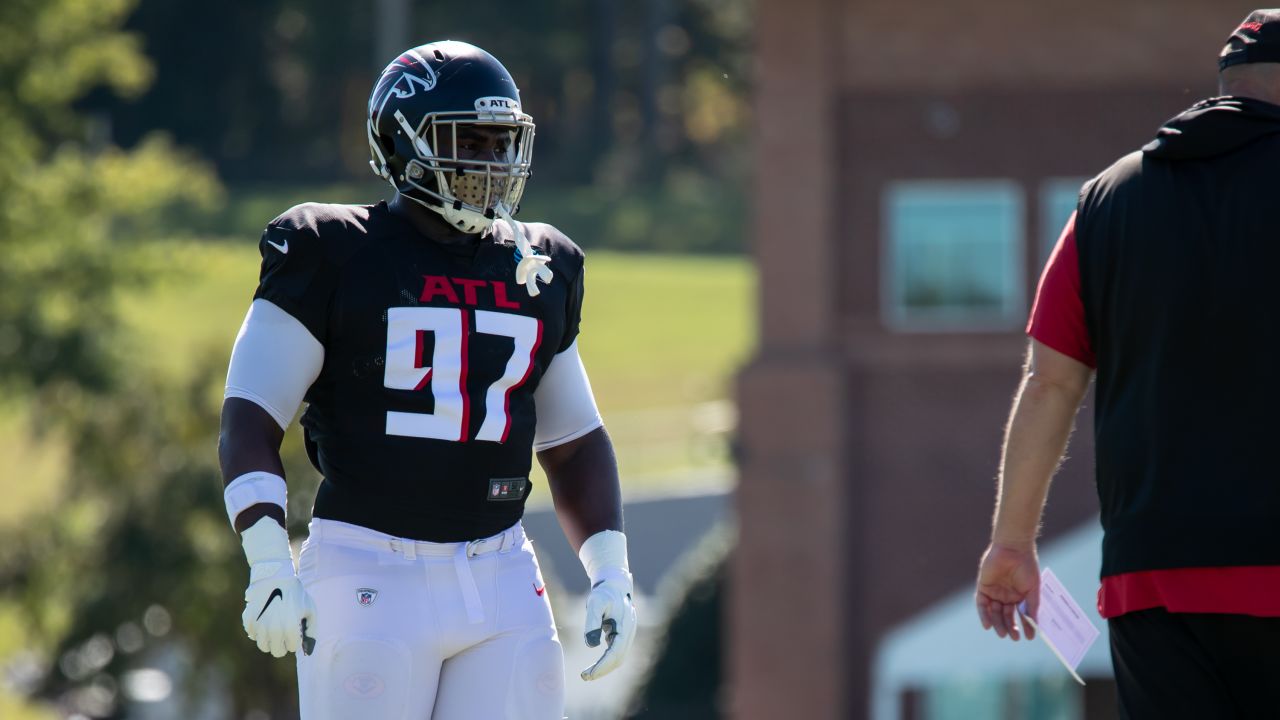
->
[[298, 637, 412, 720]]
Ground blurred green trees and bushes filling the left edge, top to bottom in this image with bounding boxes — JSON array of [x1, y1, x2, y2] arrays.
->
[[0, 0, 258, 716]]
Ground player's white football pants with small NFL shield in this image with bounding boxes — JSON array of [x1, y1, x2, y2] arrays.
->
[[298, 519, 564, 720]]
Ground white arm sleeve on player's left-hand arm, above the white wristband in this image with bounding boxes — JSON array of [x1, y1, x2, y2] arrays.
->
[[223, 299, 324, 429]]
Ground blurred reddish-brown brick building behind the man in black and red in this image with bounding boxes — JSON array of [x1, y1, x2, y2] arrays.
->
[[726, 0, 1253, 720]]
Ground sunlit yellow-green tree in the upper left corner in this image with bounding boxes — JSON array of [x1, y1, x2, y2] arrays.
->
[[0, 0, 220, 389]]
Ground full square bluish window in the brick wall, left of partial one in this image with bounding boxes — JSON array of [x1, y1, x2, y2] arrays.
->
[[882, 181, 1025, 332]]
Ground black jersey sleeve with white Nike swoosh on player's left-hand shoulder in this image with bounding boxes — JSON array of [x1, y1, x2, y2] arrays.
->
[[253, 214, 338, 345]]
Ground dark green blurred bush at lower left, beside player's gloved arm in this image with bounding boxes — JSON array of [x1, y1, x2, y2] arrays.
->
[[0, 361, 311, 717]]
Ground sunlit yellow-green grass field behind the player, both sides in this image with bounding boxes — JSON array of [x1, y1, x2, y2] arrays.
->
[[112, 241, 755, 498]]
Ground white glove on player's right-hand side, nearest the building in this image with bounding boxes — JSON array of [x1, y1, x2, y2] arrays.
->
[[579, 530, 636, 680]]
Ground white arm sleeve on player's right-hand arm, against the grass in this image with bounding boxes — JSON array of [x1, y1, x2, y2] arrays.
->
[[534, 340, 604, 452]]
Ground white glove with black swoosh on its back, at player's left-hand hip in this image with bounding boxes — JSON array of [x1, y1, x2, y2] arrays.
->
[[241, 518, 316, 657]]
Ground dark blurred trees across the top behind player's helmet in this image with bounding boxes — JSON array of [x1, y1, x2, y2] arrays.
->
[[97, 0, 751, 252]]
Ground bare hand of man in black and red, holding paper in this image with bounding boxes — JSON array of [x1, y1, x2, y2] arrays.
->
[[975, 542, 1039, 641]]
